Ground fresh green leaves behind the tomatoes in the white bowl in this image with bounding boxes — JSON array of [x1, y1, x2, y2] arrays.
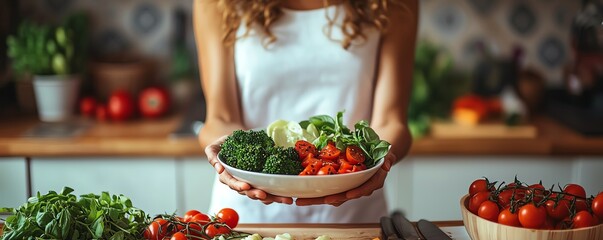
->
[[299, 112, 391, 168]]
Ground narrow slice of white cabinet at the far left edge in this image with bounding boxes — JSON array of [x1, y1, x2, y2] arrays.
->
[[0, 157, 27, 208]]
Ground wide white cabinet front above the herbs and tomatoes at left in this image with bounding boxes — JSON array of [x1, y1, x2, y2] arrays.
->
[[31, 157, 179, 216]]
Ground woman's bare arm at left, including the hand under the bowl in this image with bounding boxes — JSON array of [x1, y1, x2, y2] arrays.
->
[[193, 0, 293, 204]]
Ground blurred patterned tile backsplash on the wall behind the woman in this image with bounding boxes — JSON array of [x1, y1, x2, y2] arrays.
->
[[21, 0, 581, 85]]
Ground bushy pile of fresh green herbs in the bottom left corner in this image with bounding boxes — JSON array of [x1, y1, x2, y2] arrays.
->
[[1, 187, 150, 240]]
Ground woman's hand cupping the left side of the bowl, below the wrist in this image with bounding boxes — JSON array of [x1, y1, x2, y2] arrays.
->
[[205, 136, 293, 205]]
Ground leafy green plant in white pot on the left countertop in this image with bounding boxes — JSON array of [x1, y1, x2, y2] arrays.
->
[[7, 15, 86, 122]]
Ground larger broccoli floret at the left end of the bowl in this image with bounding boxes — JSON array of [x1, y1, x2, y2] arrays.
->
[[220, 130, 275, 172]]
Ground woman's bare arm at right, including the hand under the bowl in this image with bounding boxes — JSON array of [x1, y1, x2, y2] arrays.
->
[[296, 0, 419, 206]]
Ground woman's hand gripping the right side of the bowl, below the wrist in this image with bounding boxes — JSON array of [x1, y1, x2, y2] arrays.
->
[[295, 152, 397, 207]]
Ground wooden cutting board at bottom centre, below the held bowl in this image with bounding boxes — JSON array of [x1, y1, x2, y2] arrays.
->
[[237, 224, 381, 240]]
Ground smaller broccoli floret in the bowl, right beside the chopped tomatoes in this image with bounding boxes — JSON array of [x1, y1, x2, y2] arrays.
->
[[262, 147, 303, 175]]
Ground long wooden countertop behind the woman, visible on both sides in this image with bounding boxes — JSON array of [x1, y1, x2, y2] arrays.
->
[[0, 115, 603, 157]]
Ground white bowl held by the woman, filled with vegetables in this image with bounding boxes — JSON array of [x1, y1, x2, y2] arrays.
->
[[218, 157, 383, 198]]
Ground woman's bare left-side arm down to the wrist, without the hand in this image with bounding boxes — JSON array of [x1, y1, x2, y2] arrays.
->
[[193, 0, 243, 148]]
